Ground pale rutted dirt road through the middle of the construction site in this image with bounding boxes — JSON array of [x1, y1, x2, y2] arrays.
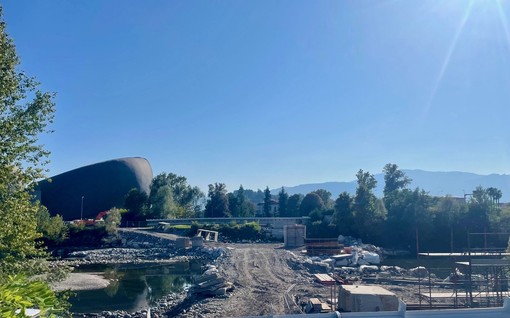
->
[[181, 244, 329, 317]]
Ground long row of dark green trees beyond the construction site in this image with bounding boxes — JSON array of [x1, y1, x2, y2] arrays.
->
[[121, 163, 510, 251]]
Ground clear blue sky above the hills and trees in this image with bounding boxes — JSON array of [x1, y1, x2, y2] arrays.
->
[[1, 0, 510, 191]]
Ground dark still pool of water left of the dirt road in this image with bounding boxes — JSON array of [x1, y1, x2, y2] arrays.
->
[[70, 263, 200, 313]]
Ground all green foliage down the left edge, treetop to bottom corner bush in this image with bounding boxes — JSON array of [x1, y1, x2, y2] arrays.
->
[[0, 6, 68, 317]]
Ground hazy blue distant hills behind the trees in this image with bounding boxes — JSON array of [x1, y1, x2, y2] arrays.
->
[[271, 169, 510, 202]]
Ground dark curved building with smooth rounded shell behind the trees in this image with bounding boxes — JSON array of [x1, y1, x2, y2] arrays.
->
[[36, 157, 152, 220]]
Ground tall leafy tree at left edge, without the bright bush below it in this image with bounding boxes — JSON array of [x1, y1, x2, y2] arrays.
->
[[0, 7, 55, 277]]
